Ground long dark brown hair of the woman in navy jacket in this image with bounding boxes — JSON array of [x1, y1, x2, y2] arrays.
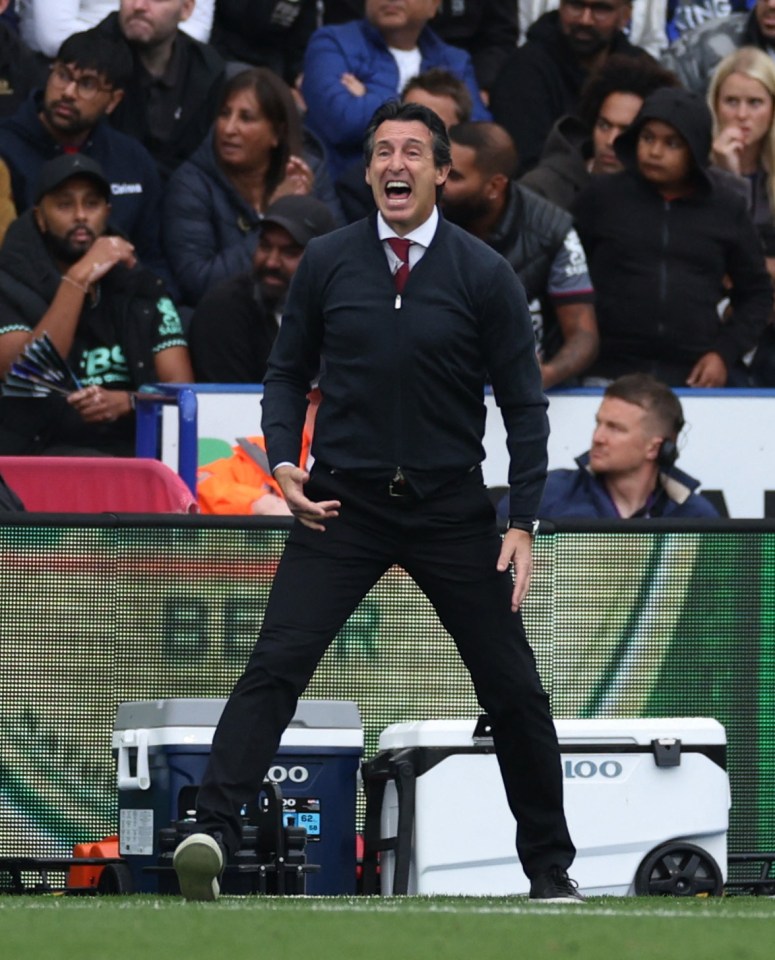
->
[[218, 67, 302, 205]]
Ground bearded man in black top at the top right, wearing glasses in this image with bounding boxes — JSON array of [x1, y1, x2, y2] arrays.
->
[[490, 0, 648, 174]]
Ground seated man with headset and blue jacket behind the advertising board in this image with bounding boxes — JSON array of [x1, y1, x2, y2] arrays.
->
[[538, 373, 718, 519]]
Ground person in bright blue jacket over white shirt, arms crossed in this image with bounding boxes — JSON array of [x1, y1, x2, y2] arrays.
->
[[302, 0, 491, 180]]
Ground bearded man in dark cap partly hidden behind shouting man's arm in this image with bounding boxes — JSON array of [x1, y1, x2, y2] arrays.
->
[[189, 196, 334, 383]]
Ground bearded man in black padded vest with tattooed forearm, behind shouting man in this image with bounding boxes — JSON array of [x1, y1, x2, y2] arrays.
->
[[442, 123, 598, 388]]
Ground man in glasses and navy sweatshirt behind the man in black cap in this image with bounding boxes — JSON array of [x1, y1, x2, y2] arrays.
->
[[0, 32, 166, 278]]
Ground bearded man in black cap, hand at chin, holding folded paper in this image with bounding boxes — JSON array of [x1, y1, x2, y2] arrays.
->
[[0, 154, 193, 456]]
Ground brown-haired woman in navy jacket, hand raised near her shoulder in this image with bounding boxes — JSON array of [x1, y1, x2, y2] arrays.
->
[[163, 67, 342, 306]]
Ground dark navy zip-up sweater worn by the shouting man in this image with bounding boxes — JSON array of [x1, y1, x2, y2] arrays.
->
[[262, 214, 548, 521]]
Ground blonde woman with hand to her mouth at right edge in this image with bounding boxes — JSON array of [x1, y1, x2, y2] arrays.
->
[[708, 47, 775, 387]]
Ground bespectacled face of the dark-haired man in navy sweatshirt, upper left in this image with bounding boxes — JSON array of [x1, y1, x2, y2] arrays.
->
[[42, 60, 124, 135]]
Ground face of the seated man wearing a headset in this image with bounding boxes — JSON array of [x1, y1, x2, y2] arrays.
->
[[589, 397, 664, 475]]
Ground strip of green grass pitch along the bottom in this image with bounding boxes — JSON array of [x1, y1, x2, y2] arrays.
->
[[0, 895, 775, 960]]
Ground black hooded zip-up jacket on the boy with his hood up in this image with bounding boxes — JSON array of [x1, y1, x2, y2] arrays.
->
[[574, 89, 772, 386]]
